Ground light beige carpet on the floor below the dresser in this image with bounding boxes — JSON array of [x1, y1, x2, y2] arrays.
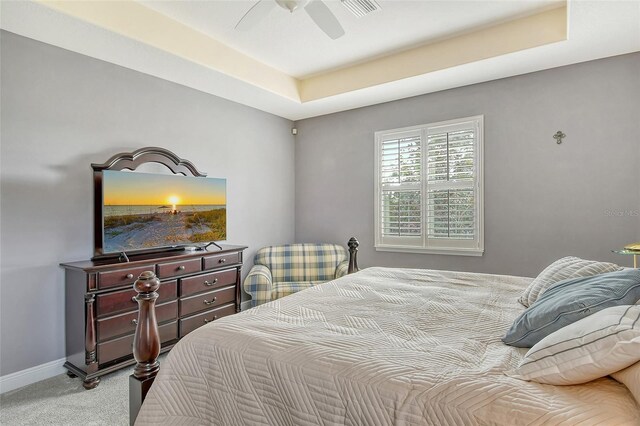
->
[[0, 356, 164, 426]]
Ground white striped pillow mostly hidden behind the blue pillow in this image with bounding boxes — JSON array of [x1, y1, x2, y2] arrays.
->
[[518, 256, 624, 308]]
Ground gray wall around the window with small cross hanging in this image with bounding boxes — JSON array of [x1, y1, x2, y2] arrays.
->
[[296, 53, 640, 276]]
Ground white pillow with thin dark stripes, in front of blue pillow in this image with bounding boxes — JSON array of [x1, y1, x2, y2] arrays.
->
[[505, 305, 640, 385]]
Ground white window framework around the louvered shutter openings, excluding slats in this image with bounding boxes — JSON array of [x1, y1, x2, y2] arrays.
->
[[374, 115, 484, 256]]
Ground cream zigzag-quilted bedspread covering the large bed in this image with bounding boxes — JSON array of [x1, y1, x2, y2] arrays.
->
[[136, 268, 640, 426]]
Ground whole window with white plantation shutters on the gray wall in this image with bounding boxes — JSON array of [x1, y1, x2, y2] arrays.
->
[[375, 116, 484, 256]]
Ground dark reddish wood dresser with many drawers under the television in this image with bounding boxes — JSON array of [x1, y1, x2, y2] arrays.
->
[[61, 246, 246, 389]]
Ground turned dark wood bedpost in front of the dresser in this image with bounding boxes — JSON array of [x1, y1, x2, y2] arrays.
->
[[129, 271, 160, 424]]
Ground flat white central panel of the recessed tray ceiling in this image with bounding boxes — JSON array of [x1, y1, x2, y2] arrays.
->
[[140, 0, 564, 78]]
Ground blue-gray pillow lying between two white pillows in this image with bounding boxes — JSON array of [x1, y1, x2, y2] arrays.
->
[[502, 269, 640, 348]]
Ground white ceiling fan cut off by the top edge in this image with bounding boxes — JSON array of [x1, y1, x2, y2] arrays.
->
[[235, 0, 344, 40]]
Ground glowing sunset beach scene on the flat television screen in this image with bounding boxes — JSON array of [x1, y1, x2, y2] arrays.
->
[[102, 170, 227, 253]]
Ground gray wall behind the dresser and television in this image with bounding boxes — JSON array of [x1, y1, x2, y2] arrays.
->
[[0, 32, 294, 375]]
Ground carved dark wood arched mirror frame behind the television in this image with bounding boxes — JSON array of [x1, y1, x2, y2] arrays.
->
[[91, 146, 207, 260]]
